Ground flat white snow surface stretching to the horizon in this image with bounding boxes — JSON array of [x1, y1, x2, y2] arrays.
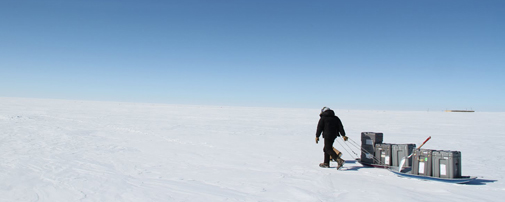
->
[[0, 98, 505, 202]]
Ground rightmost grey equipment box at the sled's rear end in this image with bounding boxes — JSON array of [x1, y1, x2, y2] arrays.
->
[[432, 150, 461, 178]]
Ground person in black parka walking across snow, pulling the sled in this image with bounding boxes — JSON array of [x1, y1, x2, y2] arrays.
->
[[316, 107, 347, 169]]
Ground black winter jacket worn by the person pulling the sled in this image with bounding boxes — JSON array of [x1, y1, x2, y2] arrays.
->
[[316, 110, 345, 139]]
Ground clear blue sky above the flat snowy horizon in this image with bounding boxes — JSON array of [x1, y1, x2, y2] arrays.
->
[[0, 0, 505, 111]]
